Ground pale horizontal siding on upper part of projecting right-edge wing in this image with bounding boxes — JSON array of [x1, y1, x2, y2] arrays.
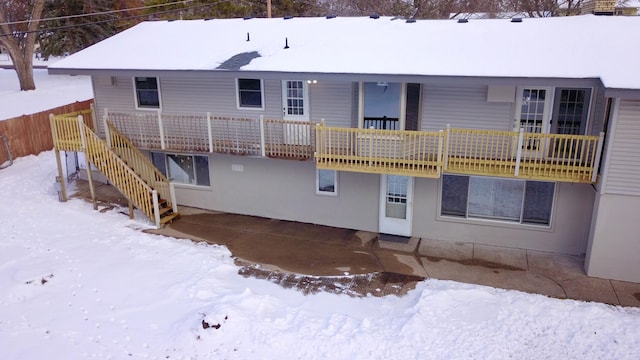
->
[[605, 100, 640, 195]]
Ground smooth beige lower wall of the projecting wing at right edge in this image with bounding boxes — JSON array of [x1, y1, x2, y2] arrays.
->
[[585, 194, 640, 282]]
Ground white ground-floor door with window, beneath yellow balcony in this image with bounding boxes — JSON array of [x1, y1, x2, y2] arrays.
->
[[379, 175, 413, 236]]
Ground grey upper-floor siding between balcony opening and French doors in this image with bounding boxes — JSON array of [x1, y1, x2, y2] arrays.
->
[[421, 84, 513, 131]]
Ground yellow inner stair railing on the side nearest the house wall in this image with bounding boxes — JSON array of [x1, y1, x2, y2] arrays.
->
[[106, 121, 177, 212]]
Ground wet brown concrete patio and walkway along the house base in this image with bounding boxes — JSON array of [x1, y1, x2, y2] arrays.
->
[[70, 181, 640, 306]]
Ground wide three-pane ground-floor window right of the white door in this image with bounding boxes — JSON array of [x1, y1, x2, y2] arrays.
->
[[440, 175, 555, 226]]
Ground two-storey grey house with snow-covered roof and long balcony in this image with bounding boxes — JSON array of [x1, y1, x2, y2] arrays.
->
[[49, 15, 640, 282]]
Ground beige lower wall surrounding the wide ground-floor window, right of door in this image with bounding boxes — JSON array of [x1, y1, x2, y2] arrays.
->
[[413, 179, 595, 255]]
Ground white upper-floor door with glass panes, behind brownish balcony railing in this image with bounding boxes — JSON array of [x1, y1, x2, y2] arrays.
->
[[282, 80, 311, 145]]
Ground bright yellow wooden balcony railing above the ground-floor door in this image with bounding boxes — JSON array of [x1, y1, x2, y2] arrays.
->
[[315, 125, 603, 183]]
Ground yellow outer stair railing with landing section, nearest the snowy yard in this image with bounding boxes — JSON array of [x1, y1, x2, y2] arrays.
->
[[50, 115, 166, 226]]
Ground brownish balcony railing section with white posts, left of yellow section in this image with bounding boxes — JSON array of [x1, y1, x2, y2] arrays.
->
[[105, 111, 315, 159]]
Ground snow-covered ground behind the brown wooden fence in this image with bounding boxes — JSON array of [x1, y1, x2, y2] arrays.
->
[[0, 53, 93, 121]]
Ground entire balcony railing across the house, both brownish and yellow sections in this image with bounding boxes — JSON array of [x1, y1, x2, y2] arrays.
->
[[106, 112, 603, 183]]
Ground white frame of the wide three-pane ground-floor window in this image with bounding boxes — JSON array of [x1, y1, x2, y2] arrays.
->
[[437, 174, 559, 231]]
